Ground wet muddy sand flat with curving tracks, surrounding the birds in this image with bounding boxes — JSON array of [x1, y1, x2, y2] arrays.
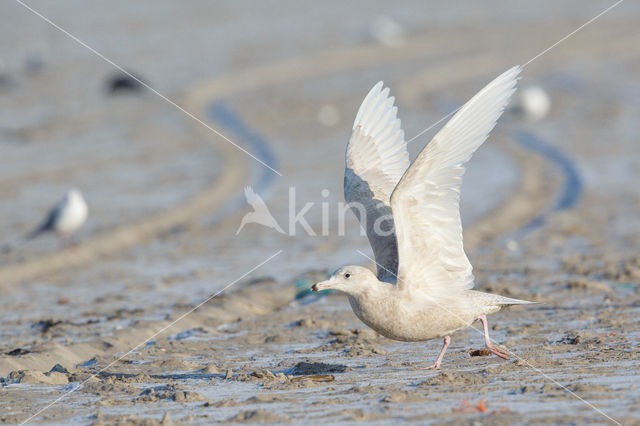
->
[[0, 0, 640, 425]]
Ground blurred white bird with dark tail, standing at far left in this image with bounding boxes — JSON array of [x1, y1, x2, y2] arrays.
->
[[27, 189, 89, 242]]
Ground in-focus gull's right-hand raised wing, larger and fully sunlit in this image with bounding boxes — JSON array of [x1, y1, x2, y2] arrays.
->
[[391, 66, 521, 298]]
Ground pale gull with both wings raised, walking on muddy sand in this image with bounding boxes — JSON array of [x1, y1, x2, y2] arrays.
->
[[312, 66, 534, 369]]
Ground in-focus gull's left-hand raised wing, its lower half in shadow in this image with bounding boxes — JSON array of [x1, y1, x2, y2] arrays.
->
[[344, 82, 409, 281]]
